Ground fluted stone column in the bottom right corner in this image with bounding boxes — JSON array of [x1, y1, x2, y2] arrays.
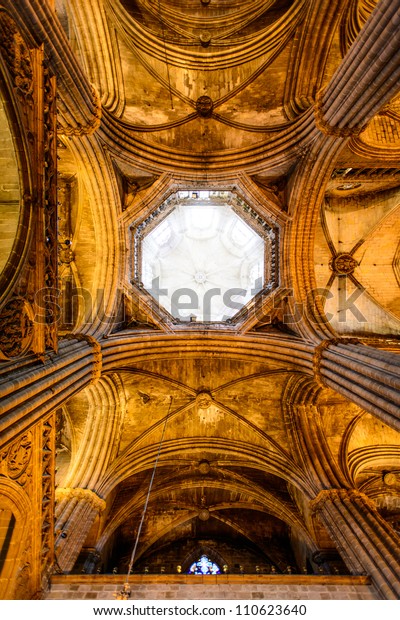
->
[[311, 489, 400, 600]]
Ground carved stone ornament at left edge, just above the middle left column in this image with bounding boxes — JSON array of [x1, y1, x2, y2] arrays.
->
[[0, 297, 34, 358]]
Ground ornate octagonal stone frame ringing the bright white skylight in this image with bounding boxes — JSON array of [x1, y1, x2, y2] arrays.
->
[[132, 186, 279, 324]]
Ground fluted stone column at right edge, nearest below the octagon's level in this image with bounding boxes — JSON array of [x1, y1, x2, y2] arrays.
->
[[314, 338, 400, 431]]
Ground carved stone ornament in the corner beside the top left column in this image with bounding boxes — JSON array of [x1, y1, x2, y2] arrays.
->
[[0, 11, 33, 105]]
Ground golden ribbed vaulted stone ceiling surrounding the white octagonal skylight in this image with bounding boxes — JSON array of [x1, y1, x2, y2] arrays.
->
[[46, 0, 400, 570]]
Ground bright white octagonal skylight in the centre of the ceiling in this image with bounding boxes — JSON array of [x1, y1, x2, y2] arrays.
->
[[139, 191, 276, 322]]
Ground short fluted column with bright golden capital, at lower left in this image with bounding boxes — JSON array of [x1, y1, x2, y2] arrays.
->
[[55, 488, 106, 572]]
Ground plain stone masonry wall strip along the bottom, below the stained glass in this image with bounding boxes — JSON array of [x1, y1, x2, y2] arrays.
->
[[47, 575, 379, 601]]
